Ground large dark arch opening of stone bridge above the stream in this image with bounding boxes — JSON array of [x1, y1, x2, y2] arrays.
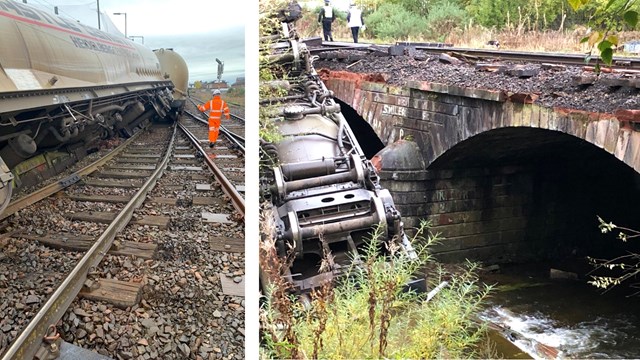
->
[[427, 127, 640, 262]]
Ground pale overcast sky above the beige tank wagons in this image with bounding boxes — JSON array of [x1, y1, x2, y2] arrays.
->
[[27, 0, 247, 84]]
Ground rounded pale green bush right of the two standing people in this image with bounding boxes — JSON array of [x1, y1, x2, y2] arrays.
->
[[365, 3, 428, 40]]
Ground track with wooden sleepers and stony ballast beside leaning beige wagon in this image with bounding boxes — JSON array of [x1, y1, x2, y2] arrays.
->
[[0, 120, 244, 359]]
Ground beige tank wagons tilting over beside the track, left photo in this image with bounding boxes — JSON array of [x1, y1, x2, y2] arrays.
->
[[0, 0, 188, 211]]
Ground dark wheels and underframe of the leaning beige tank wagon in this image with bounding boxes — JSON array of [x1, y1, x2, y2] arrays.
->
[[0, 82, 173, 168]]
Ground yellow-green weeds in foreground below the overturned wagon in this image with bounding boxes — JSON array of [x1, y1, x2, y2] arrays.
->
[[260, 221, 492, 359]]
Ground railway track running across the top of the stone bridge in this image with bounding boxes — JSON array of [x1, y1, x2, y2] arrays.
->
[[310, 42, 640, 70]]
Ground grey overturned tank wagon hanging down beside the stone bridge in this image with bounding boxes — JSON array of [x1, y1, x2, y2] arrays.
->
[[261, 9, 422, 293]]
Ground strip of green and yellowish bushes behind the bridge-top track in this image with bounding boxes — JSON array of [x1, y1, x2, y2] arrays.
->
[[358, 0, 640, 39]]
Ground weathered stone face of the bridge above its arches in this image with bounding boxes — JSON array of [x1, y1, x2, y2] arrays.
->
[[321, 70, 640, 172]]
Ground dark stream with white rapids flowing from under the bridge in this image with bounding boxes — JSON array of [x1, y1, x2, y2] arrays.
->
[[480, 264, 640, 359]]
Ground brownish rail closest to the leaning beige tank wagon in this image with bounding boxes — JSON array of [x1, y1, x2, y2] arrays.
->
[[0, 131, 142, 220]]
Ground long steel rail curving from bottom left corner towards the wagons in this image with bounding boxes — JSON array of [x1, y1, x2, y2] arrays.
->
[[2, 126, 177, 360]]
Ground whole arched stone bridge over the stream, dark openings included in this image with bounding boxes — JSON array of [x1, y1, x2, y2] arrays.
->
[[320, 69, 640, 263]]
